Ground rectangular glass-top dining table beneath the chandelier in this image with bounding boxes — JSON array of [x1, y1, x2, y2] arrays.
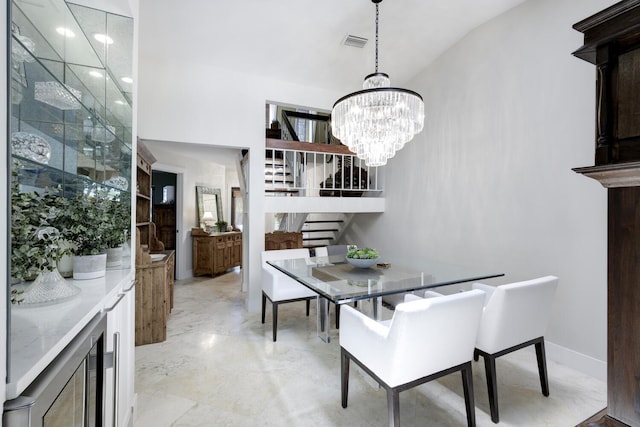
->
[[267, 255, 504, 342]]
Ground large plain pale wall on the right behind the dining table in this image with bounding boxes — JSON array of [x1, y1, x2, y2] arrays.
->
[[345, 0, 613, 379]]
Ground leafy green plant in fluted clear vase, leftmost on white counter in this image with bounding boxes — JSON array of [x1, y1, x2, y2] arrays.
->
[[11, 168, 79, 304]]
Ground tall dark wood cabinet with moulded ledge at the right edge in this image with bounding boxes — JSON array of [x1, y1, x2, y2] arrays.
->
[[574, 0, 640, 427]]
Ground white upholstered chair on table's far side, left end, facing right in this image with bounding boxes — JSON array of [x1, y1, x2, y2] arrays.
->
[[262, 249, 318, 342]]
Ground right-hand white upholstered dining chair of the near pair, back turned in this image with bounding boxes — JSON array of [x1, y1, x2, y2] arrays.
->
[[472, 276, 558, 423]]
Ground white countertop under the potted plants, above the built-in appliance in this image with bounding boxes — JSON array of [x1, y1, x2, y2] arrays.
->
[[6, 267, 135, 399]]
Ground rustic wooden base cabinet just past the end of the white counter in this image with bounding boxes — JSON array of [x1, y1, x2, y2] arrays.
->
[[135, 251, 175, 345]]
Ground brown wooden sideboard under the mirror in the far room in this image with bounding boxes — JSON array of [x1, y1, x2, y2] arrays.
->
[[191, 228, 242, 276]]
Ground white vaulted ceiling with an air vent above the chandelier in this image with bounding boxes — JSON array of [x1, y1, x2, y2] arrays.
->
[[140, 0, 524, 92]]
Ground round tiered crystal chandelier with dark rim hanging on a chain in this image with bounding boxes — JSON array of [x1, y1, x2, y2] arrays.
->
[[331, 0, 424, 166]]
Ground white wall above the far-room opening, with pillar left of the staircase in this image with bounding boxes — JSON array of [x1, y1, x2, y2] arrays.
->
[[138, 46, 340, 311]]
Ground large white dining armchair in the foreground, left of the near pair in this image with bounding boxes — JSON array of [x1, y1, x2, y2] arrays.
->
[[340, 290, 484, 426]]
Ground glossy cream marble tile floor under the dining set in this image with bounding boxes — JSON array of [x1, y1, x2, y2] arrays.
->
[[134, 271, 606, 427]]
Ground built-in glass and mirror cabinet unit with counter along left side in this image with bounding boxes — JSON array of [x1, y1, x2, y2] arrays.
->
[[3, 0, 135, 426]]
